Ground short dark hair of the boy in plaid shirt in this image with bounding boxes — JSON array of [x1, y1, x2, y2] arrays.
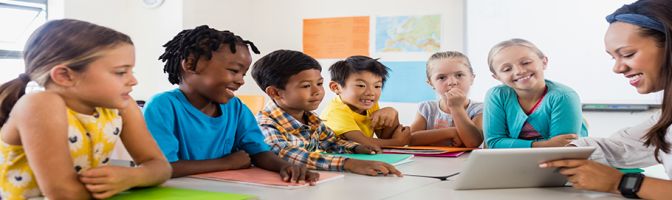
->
[[251, 50, 322, 91]]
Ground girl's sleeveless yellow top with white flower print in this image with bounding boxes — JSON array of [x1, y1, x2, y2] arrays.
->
[[0, 108, 122, 200]]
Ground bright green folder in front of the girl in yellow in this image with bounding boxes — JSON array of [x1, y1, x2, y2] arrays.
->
[[109, 186, 256, 200]]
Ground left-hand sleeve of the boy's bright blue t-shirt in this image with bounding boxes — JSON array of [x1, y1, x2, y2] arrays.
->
[[143, 96, 179, 162]]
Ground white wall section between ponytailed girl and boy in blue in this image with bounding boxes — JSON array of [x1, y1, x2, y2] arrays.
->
[[63, 0, 183, 100]]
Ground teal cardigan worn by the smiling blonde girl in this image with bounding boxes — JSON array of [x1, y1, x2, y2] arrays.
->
[[483, 80, 588, 148]]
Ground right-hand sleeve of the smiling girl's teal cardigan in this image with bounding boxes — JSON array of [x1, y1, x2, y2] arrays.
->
[[549, 91, 587, 138]]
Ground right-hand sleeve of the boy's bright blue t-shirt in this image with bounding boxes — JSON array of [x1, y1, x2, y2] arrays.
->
[[234, 98, 271, 155]]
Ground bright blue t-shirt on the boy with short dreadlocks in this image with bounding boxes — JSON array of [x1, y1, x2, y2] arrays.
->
[[143, 89, 270, 162]]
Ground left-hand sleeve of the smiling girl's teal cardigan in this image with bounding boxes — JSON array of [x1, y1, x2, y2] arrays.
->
[[483, 87, 533, 148]]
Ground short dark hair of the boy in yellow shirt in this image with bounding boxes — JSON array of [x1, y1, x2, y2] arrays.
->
[[329, 56, 390, 86]]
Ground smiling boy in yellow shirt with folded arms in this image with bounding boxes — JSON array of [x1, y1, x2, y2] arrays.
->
[[320, 56, 410, 147]]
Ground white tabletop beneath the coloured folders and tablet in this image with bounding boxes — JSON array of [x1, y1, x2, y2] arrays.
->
[[164, 154, 623, 200]]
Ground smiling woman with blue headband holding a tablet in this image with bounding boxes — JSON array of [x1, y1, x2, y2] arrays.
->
[[539, 0, 672, 199]]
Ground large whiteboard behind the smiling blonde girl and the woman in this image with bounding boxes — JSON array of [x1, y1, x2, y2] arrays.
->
[[465, 0, 662, 104]]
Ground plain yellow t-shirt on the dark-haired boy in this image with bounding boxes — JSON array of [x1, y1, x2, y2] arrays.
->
[[320, 96, 380, 137]]
